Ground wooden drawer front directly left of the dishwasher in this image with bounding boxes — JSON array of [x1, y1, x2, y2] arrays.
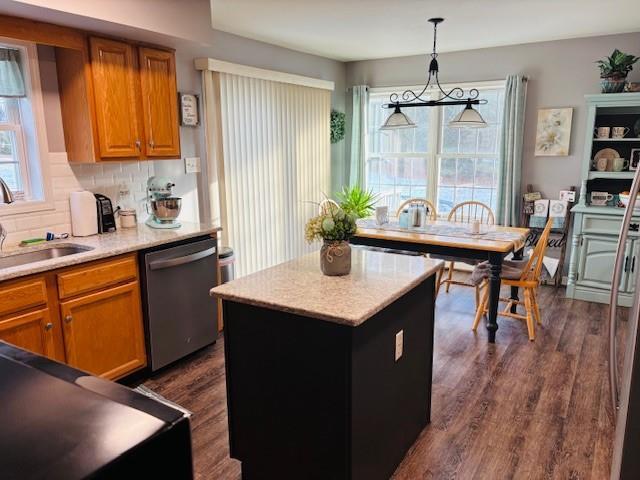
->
[[58, 255, 138, 299]]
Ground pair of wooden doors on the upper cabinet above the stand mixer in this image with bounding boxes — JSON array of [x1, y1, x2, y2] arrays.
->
[[89, 37, 180, 159]]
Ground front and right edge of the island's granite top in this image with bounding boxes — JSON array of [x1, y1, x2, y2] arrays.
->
[[209, 260, 444, 327]]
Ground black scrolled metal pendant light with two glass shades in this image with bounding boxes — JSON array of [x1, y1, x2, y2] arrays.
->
[[380, 18, 487, 130]]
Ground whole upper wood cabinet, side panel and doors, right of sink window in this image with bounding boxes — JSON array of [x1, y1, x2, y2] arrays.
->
[[56, 37, 180, 162]]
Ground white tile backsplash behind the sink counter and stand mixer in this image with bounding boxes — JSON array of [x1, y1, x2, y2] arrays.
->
[[0, 152, 154, 245]]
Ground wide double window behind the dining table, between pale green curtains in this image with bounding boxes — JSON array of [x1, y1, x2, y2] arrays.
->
[[366, 84, 504, 216]]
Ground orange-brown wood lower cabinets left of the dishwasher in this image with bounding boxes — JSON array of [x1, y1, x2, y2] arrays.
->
[[0, 254, 146, 380]]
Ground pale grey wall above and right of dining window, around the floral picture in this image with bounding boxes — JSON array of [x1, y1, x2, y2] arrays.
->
[[347, 32, 640, 198]]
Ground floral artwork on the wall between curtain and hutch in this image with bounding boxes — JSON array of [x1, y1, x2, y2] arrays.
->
[[535, 107, 573, 157]]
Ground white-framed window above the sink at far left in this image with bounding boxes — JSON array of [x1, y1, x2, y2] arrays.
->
[[0, 38, 51, 215]]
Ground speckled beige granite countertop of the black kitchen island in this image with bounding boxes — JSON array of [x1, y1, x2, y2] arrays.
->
[[211, 247, 443, 327]]
